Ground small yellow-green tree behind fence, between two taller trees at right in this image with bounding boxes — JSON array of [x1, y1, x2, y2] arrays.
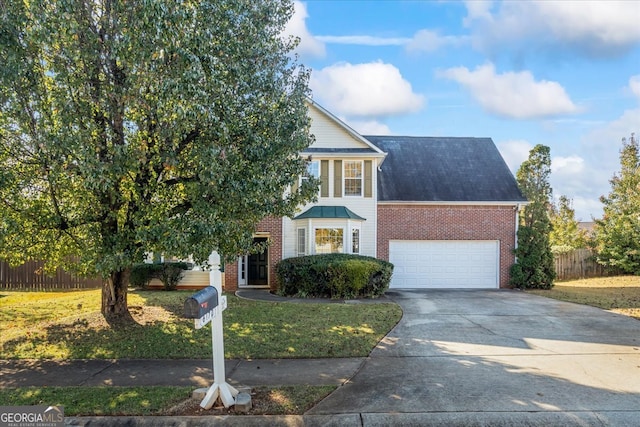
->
[[549, 196, 587, 253]]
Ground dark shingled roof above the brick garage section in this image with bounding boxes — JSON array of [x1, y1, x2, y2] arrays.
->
[[365, 136, 526, 203]]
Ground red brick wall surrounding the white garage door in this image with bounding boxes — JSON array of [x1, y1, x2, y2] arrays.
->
[[377, 205, 516, 288]]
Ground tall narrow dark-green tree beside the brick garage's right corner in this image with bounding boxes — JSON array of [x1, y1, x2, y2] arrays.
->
[[510, 144, 556, 289]]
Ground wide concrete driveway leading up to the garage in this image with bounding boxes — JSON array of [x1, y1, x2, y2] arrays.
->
[[307, 290, 640, 426]]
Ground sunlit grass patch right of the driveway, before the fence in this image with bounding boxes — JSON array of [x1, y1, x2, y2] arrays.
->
[[527, 276, 640, 320]]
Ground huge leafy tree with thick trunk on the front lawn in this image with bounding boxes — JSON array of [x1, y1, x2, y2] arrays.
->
[[0, 0, 313, 320]]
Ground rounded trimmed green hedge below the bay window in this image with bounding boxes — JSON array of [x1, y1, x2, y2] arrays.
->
[[276, 254, 393, 299]]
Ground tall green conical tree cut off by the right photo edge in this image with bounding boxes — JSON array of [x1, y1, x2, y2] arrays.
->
[[595, 134, 640, 275]]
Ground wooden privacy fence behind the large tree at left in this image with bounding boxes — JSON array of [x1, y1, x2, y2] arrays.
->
[[0, 260, 102, 291]]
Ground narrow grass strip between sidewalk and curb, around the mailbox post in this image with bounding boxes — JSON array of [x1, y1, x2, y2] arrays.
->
[[0, 386, 335, 416]]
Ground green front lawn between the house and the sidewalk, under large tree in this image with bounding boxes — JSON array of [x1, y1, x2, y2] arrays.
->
[[0, 290, 402, 359]]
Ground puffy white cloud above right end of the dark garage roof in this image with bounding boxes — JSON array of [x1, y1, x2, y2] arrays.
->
[[439, 64, 579, 119]]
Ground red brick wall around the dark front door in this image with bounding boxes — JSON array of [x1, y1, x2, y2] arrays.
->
[[223, 217, 282, 292]]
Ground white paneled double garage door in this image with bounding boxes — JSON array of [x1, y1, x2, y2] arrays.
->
[[389, 240, 499, 289]]
